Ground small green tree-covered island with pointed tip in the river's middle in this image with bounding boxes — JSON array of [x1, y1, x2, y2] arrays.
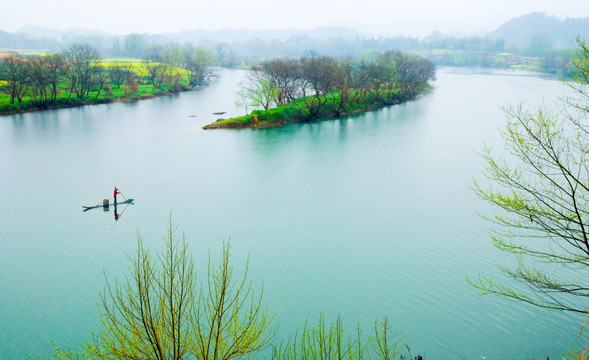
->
[[203, 51, 435, 129]]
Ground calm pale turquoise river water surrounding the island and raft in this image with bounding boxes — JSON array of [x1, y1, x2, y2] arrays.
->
[[0, 69, 583, 359]]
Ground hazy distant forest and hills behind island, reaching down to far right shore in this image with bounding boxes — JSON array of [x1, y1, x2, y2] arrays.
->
[[0, 13, 589, 73]]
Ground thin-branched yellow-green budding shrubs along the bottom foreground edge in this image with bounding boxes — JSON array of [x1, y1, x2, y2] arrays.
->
[[56, 219, 417, 360]]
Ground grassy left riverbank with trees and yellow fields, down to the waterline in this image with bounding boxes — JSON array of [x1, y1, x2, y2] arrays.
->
[[0, 44, 214, 115]]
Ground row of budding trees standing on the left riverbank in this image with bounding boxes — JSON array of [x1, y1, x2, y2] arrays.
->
[[0, 43, 215, 106]]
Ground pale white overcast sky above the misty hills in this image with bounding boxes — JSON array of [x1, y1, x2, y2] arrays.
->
[[0, 0, 589, 35]]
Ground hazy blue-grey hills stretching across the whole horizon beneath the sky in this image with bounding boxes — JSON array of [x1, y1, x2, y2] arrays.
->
[[0, 13, 589, 58]]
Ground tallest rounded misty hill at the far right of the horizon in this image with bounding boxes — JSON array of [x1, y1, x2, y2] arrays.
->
[[487, 12, 589, 49]]
